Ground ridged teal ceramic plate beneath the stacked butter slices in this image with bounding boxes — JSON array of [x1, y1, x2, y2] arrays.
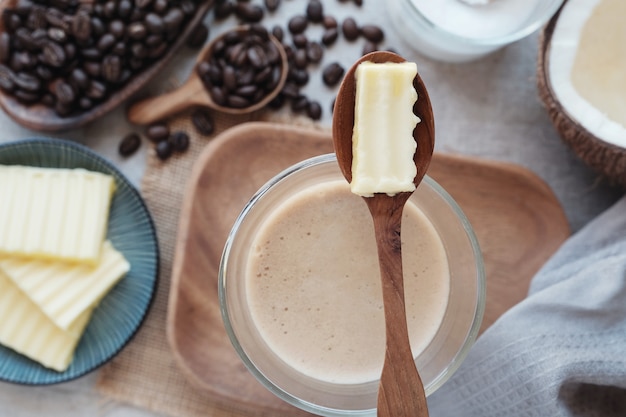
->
[[0, 139, 159, 385]]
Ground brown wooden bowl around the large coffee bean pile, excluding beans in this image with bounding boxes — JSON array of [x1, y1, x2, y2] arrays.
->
[[0, 0, 215, 132]]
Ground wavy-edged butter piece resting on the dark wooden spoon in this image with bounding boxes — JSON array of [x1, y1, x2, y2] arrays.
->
[[350, 62, 419, 197]]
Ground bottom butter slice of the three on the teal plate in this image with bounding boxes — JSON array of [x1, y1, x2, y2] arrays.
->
[[0, 271, 93, 372]]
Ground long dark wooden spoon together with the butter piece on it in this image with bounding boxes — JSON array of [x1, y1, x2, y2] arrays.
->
[[332, 52, 435, 417]]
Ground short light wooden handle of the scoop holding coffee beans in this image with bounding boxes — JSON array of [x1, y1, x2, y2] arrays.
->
[[128, 74, 213, 125]]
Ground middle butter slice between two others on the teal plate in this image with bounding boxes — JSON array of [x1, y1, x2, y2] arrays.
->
[[0, 240, 130, 330]]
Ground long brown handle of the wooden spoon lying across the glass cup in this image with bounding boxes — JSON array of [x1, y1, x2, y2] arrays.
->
[[365, 193, 428, 417]]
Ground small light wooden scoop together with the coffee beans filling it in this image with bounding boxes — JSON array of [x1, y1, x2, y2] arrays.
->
[[128, 24, 289, 125]]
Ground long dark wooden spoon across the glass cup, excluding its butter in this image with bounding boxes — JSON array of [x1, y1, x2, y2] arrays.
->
[[332, 52, 435, 417]]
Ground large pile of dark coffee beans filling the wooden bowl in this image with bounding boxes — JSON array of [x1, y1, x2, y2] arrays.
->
[[0, 0, 201, 117]]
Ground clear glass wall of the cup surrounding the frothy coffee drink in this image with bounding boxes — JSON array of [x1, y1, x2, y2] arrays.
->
[[218, 154, 485, 416]]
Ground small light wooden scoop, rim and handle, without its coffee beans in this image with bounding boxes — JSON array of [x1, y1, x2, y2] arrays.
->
[[128, 26, 288, 125]]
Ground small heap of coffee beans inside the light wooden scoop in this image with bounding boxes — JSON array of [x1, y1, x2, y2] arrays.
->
[[196, 23, 283, 109]]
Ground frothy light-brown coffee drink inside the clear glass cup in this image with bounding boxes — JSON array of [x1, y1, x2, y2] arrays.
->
[[246, 180, 450, 384]]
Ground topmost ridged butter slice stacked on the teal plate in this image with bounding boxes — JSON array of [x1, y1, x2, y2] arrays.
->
[[0, 165, 115, 264]]
